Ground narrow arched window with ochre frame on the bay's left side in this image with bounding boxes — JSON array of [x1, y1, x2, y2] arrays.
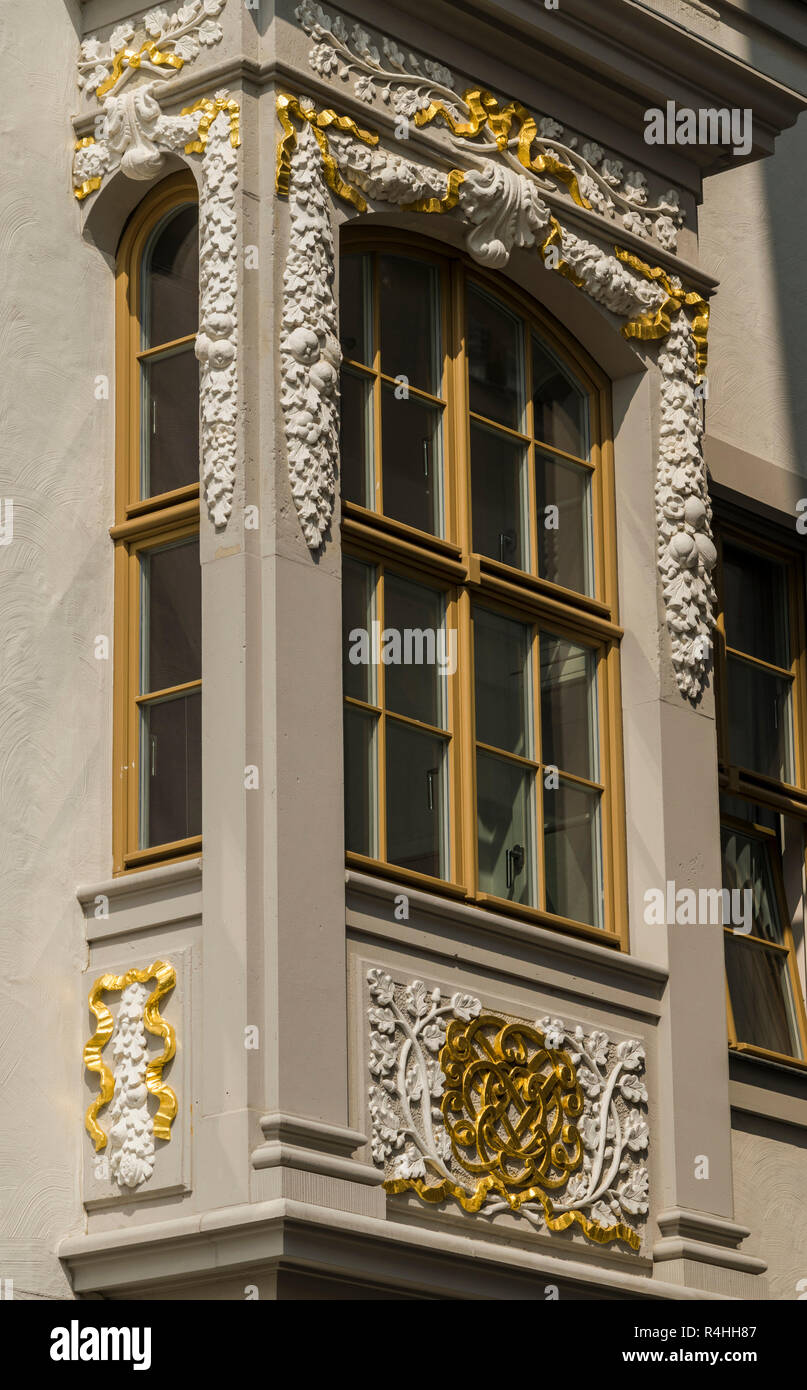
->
[[111, 175, 201, 873]]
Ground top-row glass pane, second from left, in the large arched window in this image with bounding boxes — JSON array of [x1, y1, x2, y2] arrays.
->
[[378, 256, 442, 396]]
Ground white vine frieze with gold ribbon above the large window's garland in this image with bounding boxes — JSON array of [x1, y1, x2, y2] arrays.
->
[[294, 0, 683, 250]]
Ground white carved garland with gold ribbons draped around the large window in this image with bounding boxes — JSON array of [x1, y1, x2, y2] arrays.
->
[[276, 93, 717, 701]]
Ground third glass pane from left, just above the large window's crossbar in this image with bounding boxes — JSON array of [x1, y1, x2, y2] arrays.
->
[[471, 424, 529, 570]]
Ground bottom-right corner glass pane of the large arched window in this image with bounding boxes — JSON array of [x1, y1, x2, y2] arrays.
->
[[543, 777, 603, 927]]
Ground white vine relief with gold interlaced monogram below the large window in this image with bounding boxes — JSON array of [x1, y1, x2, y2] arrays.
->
[[367, 969, 649, 1250]]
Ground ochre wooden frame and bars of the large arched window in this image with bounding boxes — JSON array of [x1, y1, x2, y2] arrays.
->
[[340, 227, 628, 951]]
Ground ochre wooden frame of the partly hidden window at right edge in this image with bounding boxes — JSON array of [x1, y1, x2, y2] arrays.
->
[[715, 512, 807, 1070]]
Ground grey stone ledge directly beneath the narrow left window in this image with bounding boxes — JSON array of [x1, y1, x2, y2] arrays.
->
[[75, 858, 201, 944]]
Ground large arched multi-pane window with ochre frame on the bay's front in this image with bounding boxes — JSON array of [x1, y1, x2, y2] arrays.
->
[[340, 235, 625, 942]]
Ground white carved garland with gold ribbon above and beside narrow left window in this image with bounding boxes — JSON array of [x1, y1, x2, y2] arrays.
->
[[74, 0, 240, 527]]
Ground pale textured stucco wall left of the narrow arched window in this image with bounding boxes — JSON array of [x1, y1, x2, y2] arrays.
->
[[0, 0, 113, 1297]]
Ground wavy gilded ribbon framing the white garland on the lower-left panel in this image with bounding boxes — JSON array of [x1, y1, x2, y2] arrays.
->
[[83, 960, 176, 1152]]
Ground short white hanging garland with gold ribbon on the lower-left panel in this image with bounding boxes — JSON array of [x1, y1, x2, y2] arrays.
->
[[83, 960, 176, 1187]]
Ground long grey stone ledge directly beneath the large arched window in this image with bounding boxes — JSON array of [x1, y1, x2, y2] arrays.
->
[[344, 869, 668, 988]]
